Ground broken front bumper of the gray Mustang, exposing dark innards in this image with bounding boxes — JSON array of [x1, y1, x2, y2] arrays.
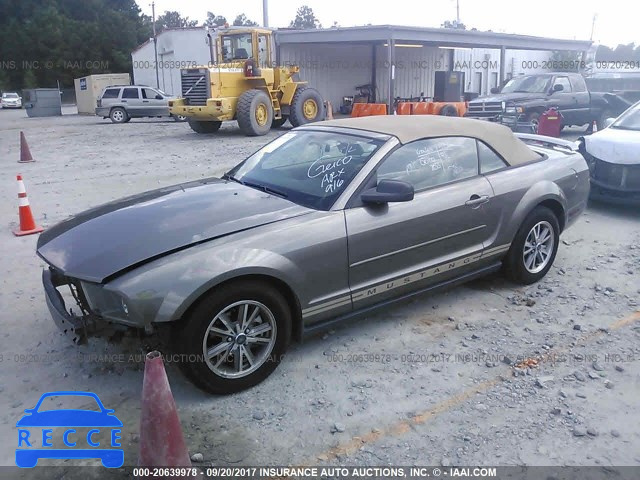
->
[[42, 268, 126, 345]]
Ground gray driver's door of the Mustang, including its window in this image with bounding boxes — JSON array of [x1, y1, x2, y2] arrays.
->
[[345, 137, 498, 309]]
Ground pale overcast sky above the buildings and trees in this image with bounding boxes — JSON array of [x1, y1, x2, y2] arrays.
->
[[137, 0, 640, 47]]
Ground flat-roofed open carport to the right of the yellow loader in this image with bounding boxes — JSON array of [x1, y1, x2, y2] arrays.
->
[[275, 25, 592, 112]]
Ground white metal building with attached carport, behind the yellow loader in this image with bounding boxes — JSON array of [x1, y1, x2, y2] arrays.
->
[[132, 25, 591, 108]]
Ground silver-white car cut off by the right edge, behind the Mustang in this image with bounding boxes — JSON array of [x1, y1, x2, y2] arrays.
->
[[579, 102, 640, 203]]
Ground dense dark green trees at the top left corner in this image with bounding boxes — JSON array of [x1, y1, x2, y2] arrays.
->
[[0, 0, 152, 90]]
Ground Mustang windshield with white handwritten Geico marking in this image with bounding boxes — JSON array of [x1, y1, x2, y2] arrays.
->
[[225, 131, 384, 210]]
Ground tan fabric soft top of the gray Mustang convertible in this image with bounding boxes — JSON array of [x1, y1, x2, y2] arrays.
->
[[307, 115, 540, 165]]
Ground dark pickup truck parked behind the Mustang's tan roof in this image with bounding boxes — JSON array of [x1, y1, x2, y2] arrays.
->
[[465, 72, 631, 133]]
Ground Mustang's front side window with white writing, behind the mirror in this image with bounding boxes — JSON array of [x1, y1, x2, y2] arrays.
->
[[377, 137, 478, 191]]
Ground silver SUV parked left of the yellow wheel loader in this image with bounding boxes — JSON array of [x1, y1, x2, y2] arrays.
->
[[96, 85, 186, 123]]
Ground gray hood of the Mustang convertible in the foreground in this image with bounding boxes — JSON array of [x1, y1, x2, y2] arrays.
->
[[37, 178, 312, 283]]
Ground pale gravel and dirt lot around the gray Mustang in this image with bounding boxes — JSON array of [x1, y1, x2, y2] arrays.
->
[[0, 107, 640, 474]]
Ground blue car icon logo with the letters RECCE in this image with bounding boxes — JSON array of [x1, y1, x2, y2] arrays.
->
[[16, 391, 124, 468]]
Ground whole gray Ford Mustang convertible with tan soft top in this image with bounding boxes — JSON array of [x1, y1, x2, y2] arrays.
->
[[38, 116, 589, 393]]
